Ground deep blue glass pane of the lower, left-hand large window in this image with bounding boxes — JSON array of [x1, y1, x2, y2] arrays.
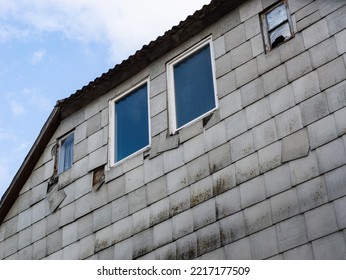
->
[[115, 84, 149, 161]]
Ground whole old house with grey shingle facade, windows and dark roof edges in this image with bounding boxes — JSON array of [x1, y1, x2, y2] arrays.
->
[[0, 0, 346, 259]]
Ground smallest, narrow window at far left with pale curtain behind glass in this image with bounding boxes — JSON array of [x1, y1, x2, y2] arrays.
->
[[58, 132, 74, 174]]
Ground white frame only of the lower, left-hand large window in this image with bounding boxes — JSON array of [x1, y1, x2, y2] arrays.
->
[[108, 77, 151, 168]]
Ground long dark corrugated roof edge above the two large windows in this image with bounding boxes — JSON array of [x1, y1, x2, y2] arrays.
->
[[59, 0, 244, 119]]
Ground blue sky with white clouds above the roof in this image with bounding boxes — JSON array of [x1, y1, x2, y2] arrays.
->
[[0, 0, 210, 197]]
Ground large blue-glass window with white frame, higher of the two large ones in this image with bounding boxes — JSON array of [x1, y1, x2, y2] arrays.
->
[[167, 38, 217, 133]]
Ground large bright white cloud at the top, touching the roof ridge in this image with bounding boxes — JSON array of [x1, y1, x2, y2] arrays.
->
[[0, 0, 210, 60]]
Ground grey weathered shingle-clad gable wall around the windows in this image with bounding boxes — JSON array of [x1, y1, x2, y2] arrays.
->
[[0, 0, 346, 259]]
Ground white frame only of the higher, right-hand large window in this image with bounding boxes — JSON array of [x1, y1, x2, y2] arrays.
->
[[166, 36, 219, 134]]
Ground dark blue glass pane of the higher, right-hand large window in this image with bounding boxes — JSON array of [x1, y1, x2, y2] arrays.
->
[[174, 45, 215, 128]]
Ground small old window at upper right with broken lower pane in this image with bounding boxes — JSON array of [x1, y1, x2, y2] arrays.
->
[[261, 1, 293, 52]]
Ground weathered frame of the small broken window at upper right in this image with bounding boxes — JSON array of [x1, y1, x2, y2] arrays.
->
[[260, 0, 294, 53]]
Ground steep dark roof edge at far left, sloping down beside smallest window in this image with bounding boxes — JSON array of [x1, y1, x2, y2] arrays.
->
[[0, 107, 61, 224]]
